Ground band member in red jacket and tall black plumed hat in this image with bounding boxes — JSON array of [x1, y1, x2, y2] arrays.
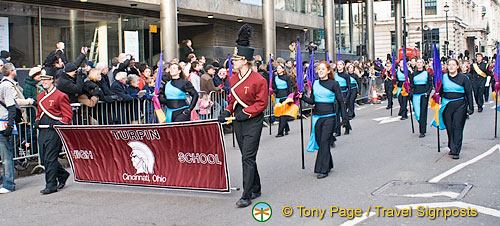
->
[[219, 24, 268, 207]]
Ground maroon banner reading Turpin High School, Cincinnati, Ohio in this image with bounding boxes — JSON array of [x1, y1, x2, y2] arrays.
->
[[56, 121, 230, 192]]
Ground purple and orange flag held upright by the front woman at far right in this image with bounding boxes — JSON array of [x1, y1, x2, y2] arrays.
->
[[429, 43, 443, 129]]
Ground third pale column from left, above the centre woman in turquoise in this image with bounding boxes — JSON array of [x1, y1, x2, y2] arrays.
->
[[323, 0, 336, 61]]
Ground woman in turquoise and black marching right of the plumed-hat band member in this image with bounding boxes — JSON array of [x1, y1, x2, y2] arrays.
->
[[301, 61, 348, 179]]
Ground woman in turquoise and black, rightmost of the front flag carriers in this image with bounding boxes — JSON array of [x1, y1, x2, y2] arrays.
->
[[438, 59, 474, 159]]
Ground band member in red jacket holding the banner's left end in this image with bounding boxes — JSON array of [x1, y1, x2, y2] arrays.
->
[[35, 74, 73, 195]]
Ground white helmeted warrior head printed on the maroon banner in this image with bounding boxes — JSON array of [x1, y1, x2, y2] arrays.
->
[[128, 141, 155, 174]]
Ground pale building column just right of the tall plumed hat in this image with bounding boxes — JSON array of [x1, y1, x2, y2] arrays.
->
[[262, 0, 277, 62]]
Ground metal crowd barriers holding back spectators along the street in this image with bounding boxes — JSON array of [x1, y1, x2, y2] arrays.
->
[[0, 82, 386, 167]]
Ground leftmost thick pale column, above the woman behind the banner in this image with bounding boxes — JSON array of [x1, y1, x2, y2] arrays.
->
[[160, 0, 179, 62]]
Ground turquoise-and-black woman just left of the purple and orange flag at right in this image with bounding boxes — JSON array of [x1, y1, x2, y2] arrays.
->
[[410, 59, 434, 138]]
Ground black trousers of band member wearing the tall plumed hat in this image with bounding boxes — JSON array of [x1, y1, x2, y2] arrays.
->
[[233, 112, 264, 199]]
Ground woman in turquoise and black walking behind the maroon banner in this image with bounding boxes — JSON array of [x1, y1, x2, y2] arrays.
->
[[158, 63, 198, 122]]
